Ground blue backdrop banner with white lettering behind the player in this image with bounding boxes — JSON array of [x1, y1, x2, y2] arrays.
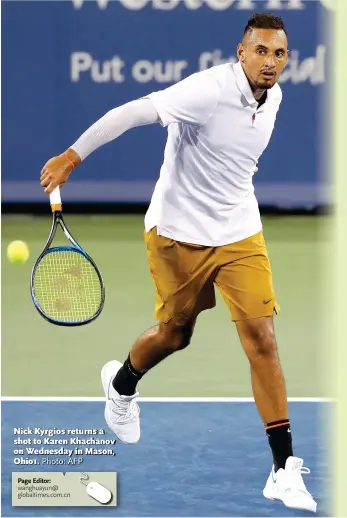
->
[[2, 0, 331, 207]]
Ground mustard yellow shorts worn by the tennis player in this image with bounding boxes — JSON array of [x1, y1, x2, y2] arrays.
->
[[145, 227, 279, 325]]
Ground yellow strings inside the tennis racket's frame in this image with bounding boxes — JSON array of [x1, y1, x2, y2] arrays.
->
[[33, 249, 102, 322]]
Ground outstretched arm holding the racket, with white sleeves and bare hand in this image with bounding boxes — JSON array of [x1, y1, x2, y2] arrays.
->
[[40, 72, 219, 194]]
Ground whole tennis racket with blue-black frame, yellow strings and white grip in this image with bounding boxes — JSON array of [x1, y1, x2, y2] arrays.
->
[[30, 187, 105, 326]]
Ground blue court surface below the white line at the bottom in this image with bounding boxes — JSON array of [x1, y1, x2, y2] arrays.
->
[[2, 401, 332, 517]]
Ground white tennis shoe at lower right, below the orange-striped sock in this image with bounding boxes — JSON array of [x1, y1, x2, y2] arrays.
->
[[263, 457, 317, 513]]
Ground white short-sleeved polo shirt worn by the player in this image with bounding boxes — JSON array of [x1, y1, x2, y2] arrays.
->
[[145, 62, 282, 246]]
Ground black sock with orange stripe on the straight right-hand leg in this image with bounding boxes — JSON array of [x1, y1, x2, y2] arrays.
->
[[265, 419, 293, 471]]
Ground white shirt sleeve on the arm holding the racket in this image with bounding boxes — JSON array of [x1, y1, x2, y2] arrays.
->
[[147, 71, 220, 127]]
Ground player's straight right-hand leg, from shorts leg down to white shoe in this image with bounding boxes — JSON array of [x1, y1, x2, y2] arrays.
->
[[216, 233, 316, 511]]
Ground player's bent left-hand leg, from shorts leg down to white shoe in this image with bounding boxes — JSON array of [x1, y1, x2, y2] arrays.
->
[[101, 229, 215, 442]]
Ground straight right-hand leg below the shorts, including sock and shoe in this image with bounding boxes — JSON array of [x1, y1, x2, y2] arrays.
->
[[236, 314, 317, 512]]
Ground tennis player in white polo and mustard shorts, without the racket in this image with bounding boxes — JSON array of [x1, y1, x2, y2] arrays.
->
[[41, 14, 316, 512]]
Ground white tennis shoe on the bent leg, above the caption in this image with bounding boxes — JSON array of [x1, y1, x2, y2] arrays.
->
[[101, 360, 140, 444]]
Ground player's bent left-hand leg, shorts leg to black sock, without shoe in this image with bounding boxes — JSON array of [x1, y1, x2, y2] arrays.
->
[[114, 228, 216, 394]]
